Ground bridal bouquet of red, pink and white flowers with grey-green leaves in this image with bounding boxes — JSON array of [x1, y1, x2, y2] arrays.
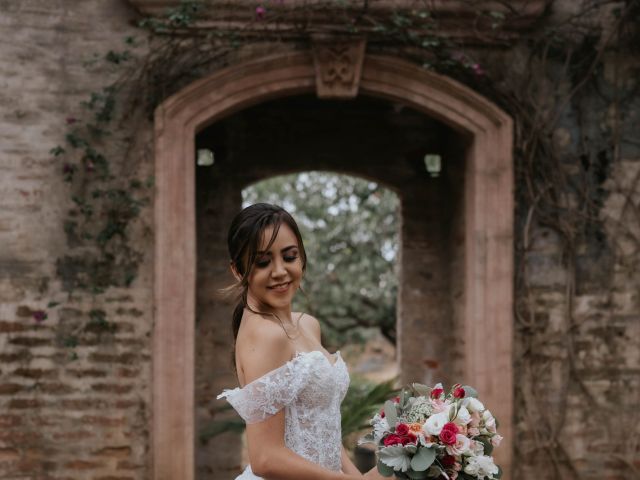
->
[[359, 383, 502, 480]]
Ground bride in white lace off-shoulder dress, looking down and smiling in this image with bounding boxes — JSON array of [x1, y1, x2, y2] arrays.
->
[[218, 203, 382, 480]]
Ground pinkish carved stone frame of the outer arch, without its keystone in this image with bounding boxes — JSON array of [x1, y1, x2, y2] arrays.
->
[[152, 52, 513, 480]]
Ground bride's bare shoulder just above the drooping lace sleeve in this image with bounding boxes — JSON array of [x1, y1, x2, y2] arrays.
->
[[236, 314, 293, 385]]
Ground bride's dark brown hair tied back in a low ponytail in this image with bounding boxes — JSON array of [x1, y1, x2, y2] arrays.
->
[[227, 203, 307, 348]]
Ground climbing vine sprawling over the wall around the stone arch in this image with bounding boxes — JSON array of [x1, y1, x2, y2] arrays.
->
[[41, 0, 640, 476]]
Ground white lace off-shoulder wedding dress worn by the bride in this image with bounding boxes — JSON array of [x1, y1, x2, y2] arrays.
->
[[218, 350, 349, 480]]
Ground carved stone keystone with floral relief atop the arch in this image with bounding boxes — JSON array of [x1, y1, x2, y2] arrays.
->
[[312, 37, 366, 99]]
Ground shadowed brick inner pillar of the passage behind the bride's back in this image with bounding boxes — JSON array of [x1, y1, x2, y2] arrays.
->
[[195, 164, 242, 480]]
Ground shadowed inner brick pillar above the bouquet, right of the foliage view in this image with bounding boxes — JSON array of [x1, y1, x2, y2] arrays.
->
[[397, 177, 451, 385]]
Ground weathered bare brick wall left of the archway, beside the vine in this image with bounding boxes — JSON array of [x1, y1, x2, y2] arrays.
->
[[0, 0, 152, 480]]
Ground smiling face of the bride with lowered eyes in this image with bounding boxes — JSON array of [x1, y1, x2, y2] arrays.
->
[[248, 223, 302, 311]]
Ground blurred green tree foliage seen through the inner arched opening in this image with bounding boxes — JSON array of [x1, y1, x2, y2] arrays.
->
[[244, 172, 399, 346]]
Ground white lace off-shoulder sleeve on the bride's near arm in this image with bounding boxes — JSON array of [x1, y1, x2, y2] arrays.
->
[[217, 359, 307, 423]]
